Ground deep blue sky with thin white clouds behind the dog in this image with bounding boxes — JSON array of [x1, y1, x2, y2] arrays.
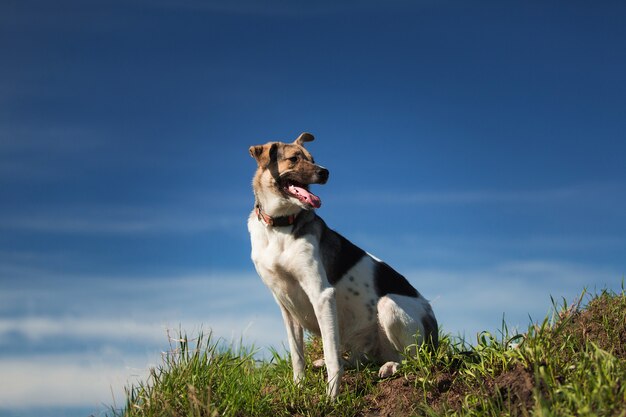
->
[[0, 0, 626, 416]]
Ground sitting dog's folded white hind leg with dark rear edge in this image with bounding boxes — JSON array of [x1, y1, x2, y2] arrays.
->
[[377, 294, 438, 378]]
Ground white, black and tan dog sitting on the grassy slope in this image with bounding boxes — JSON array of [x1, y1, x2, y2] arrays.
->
[[248, 133, 438, 398]]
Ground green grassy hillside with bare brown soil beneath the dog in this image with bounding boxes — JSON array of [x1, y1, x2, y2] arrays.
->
[[111, 290, 626, 417]]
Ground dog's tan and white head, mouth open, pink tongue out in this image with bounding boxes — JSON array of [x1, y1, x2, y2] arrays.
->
[[250, 133, 328, 210]]
